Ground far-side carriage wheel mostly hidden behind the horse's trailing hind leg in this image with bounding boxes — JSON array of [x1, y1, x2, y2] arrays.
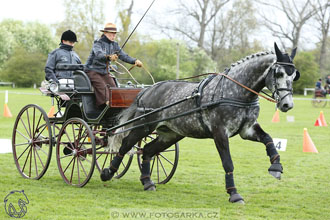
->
[[96, 151, 134, 179]]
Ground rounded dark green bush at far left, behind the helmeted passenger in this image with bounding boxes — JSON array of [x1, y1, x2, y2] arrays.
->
[[1, 46, 46, 87]]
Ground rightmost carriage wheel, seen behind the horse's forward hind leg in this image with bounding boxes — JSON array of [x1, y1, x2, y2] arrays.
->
[[137, 133, 179, 184]]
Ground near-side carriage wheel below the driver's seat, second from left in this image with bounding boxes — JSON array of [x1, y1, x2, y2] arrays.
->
[[56, 118, 96, 187]]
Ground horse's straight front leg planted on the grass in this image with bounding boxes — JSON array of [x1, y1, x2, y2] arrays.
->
[[212, 126, 244, 203]]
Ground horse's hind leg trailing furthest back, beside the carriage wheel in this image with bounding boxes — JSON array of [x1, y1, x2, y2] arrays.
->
[[101, 129, 149, 181]]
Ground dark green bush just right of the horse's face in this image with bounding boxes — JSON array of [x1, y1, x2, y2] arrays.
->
[[293, 52, 321, 93]]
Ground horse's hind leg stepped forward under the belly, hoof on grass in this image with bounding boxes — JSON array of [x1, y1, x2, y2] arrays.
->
[[140, 130, 183, 191]]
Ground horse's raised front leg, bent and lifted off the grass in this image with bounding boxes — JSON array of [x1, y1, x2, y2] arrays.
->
[[240, 123, 283, 179]]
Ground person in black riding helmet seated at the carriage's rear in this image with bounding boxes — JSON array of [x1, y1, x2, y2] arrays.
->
[[45, 30, 81, 83]]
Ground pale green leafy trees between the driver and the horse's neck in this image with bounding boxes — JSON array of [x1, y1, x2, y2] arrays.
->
[[119, 39, 216, 84]]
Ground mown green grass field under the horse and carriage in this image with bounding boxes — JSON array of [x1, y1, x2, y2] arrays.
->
[[0, 87, 330, 220]]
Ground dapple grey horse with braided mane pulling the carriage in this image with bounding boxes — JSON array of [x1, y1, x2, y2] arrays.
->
[[101, 43, 300, 203]]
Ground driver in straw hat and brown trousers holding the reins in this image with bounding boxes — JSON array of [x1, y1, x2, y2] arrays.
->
[[85, 23, 142, 107]]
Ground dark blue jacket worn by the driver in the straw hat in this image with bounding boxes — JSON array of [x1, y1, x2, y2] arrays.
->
[[86, 35, 136, 75]]
